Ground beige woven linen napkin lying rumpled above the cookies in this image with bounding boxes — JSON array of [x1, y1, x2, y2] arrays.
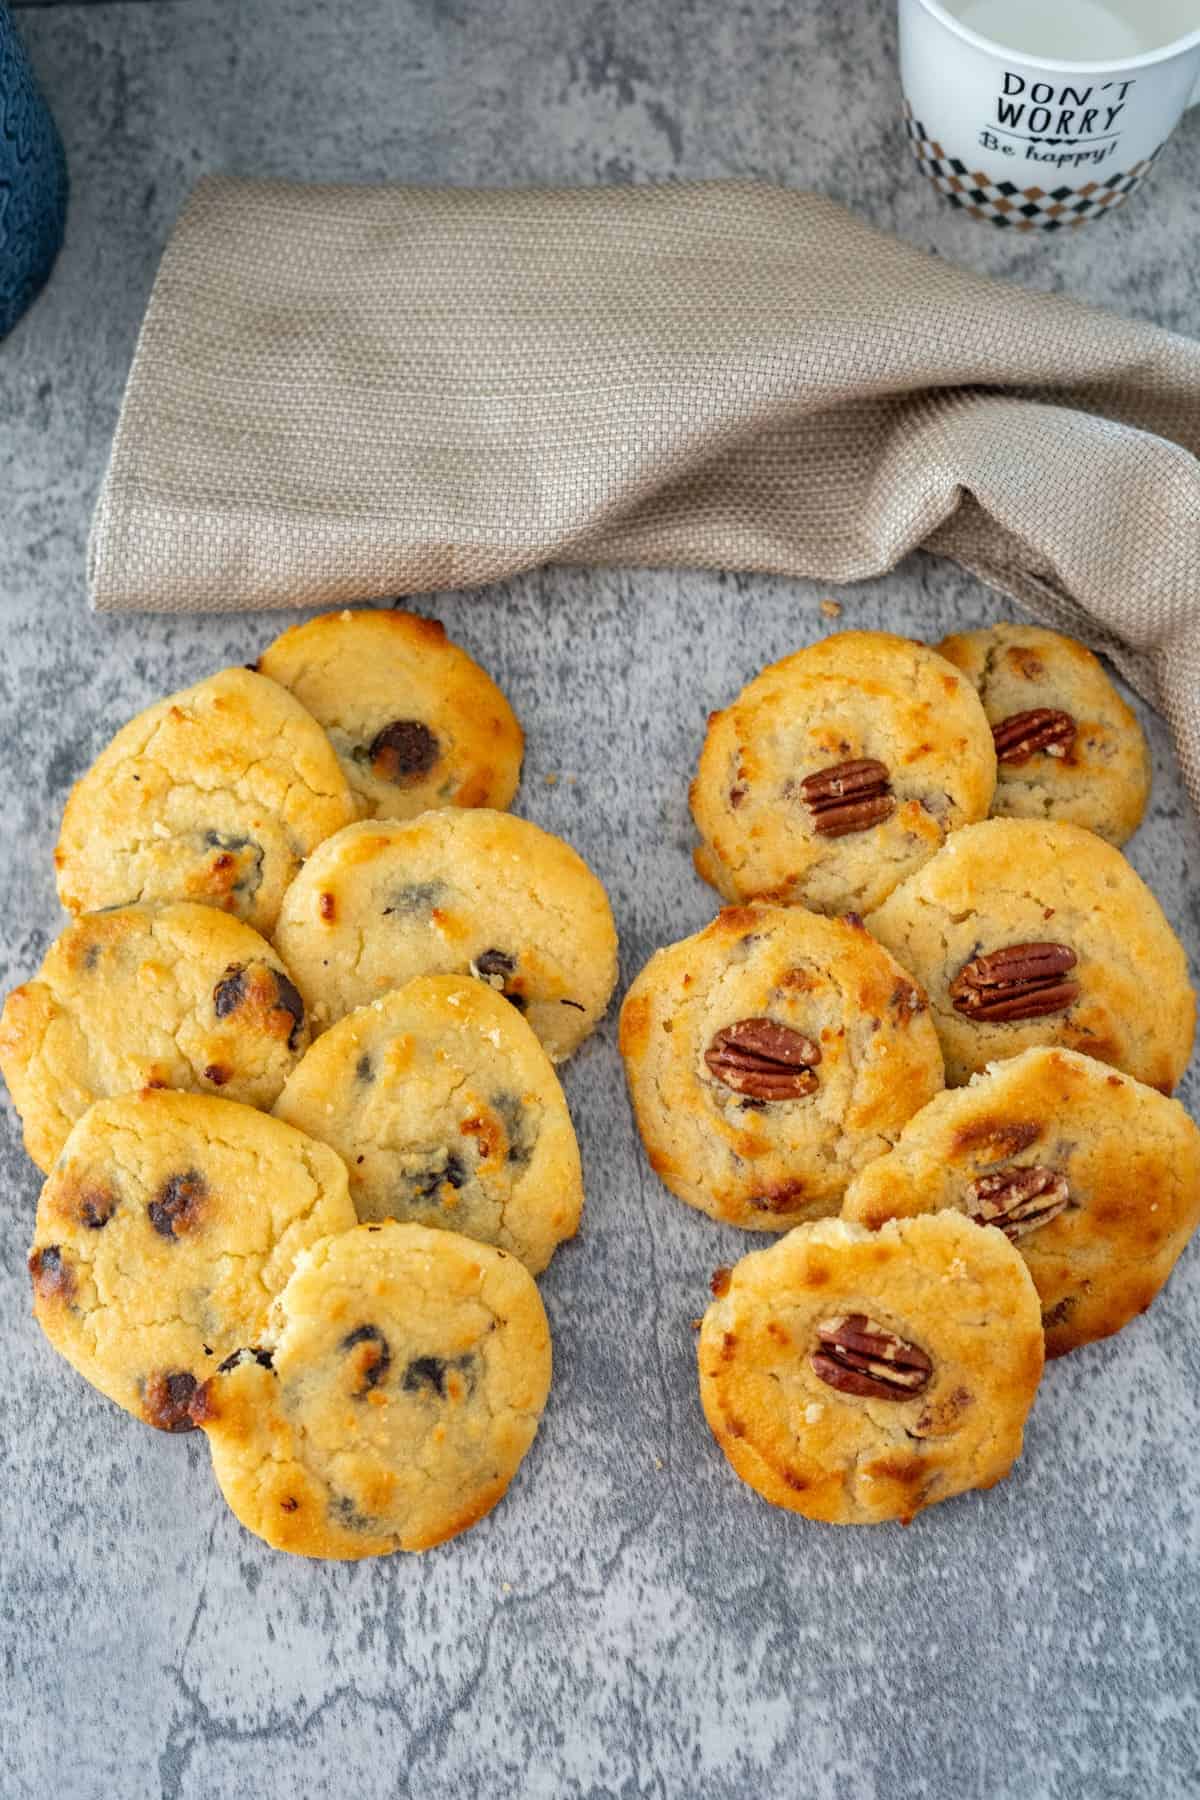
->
[[90, 178, 1200, 797]]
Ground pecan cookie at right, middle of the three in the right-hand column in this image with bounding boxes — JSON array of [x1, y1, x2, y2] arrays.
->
[[867, 819, 1196, 1094]]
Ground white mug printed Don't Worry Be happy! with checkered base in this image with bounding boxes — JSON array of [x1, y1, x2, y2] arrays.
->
[[900, 0, 1200, 230]]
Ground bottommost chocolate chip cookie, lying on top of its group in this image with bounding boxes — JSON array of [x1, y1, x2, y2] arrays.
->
[[193, 1224, 551, 1561]]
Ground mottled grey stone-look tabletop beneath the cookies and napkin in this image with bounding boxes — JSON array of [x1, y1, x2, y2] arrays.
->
[[0, 0, 1200, 1800]]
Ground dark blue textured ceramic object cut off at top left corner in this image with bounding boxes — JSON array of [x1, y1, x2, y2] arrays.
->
[[0, 0, 67, 337]]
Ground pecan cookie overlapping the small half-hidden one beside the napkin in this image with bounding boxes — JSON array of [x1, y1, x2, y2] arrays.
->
[[691, 632, 995, 913]]
